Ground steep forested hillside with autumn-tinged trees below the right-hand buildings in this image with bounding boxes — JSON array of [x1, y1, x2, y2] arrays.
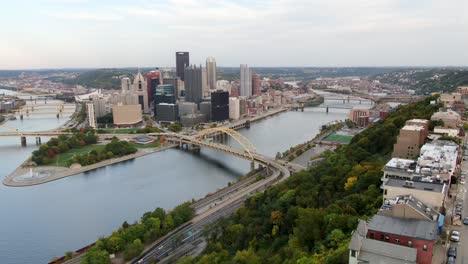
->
[[179, 95, 438, 264]]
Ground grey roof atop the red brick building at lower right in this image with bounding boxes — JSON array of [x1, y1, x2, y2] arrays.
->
[[368, 215, 438, 242]]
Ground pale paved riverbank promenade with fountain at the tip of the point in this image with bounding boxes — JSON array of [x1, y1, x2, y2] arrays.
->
[[3, 144, 176, 187]]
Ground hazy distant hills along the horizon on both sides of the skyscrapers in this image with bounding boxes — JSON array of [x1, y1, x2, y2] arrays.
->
[[0, 67, 468, 94]]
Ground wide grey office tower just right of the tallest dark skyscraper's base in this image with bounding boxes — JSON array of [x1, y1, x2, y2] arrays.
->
[[184, 65, 203, 104]]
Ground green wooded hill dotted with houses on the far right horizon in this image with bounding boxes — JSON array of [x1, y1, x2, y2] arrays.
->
[[372, 68, 468, 95]]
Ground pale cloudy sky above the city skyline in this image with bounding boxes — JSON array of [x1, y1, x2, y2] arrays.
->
[[0, 0, 468, 69]]
